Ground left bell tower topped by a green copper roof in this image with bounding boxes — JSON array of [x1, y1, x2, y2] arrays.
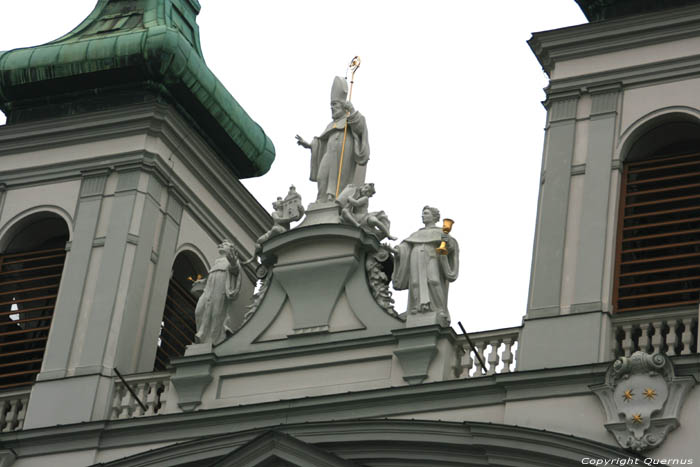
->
[[0, 0, 275, 429]]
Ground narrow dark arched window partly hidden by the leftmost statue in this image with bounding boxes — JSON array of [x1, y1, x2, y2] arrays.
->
[[153, 251, 207, 371]]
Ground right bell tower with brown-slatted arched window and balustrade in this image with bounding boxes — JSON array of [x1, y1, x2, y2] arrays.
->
[[519, 0, 700, 370]]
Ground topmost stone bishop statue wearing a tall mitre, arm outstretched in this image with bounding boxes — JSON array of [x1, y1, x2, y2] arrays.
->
[[296, 76, 369, 202]]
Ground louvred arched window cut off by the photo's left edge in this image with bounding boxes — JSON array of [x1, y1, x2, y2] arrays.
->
[[0, 213, 69, 389]]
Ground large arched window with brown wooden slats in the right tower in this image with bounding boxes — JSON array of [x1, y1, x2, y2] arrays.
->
[[613, 121, 700, 312]]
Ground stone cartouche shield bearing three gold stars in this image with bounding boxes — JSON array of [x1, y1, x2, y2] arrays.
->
[[590, 351, 695, 452]]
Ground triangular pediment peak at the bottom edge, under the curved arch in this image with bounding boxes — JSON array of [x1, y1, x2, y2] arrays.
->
[[212, 431, 358, 467]]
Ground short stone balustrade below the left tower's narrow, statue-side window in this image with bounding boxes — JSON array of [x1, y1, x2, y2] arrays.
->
[[111, 372, 170, 420]]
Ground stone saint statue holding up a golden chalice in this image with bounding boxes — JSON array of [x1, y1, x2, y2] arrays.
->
[[392, 206, 459, 326]]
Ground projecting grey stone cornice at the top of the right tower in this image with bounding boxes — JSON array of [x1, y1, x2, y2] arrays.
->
[[528, 5, 700, 74]]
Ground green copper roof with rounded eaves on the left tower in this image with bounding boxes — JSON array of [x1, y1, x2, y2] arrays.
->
[[0, 0, 275, 178]]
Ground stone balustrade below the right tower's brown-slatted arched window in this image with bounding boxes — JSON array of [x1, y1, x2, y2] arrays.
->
[[613, 308, 698, 358]]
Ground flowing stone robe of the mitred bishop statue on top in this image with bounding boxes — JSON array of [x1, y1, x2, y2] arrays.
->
[[309, 111, 369, 201]]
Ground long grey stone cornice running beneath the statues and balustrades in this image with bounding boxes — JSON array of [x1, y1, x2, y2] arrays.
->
[[8, 355, 700, 456]]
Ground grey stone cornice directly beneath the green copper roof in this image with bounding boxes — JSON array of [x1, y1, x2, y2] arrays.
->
[[0, 102, 271, 247]]
